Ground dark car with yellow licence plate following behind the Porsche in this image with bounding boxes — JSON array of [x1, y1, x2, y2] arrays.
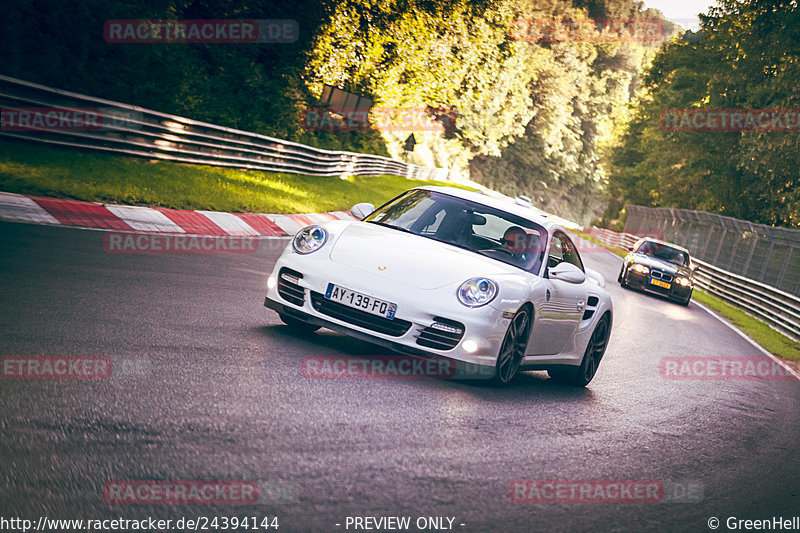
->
[[617, 238, 697, 305]]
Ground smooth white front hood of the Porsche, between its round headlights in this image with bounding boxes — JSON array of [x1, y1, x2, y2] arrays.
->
[[330, 222, 523, 289]]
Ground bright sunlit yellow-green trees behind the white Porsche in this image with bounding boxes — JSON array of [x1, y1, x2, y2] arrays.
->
[[305, 0, 675, 222]]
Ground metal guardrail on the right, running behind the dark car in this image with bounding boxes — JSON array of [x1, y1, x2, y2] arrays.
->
[[587, 228, 800, 341]]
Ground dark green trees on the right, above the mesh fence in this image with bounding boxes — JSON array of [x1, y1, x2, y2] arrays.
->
[[605, 0, 800, 226]]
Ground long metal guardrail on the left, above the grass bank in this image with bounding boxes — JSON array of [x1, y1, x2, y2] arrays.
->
[[0, 76, 447, 180]]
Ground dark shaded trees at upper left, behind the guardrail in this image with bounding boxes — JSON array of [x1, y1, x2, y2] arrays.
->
[[0, 0, 332, 144]]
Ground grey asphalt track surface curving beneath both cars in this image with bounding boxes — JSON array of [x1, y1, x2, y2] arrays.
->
[[0, 218, 800, 532]]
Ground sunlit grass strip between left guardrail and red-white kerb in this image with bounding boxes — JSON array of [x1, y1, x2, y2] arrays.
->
[[0, 140, 476, 213]]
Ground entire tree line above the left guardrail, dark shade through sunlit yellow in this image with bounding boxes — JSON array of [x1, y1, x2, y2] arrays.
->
[[0, 0, 680, 222]]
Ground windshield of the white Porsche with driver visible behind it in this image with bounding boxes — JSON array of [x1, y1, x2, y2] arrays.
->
[[364, 190, 547, 274]]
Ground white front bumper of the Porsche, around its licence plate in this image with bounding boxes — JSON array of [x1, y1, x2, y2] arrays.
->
[[264, 248, 509, 378]]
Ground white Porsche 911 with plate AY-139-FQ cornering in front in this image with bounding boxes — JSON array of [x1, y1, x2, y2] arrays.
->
[[264, 187, 613, 386]]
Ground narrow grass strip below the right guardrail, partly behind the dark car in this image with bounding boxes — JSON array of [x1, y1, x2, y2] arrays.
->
[[573, 231, 800, 361]]
